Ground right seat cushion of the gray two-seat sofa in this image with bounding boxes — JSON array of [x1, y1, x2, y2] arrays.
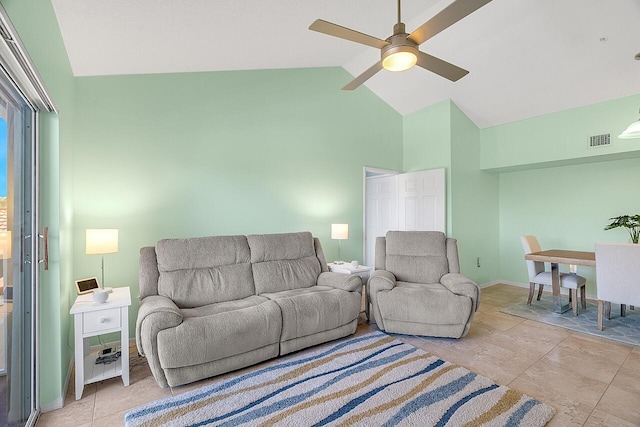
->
[[262, 286, 361, 341]]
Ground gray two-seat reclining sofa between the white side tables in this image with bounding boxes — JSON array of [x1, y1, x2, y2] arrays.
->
[[136, 232, 362, 387]]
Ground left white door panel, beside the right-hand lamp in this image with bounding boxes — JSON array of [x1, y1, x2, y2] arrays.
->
[[364, 175, 398, 267]]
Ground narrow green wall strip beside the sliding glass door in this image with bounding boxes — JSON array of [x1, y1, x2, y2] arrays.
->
[[0, 0, 75, 409]]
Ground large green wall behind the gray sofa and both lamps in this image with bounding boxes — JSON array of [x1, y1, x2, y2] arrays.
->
[[73, 68, 402, 336]]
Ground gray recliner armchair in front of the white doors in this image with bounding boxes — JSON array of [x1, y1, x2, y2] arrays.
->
[[367, 231, 480, 338]]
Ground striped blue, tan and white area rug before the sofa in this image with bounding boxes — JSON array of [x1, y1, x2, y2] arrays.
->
[[125, 332, 555, 427]]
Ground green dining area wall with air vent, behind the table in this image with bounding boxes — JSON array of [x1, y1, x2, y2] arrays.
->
[[481, 95, 640, 296]]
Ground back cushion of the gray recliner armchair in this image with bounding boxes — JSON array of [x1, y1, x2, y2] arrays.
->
[[385, 231, 449, 283]]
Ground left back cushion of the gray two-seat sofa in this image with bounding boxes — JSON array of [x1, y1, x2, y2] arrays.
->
[[156, 236, 255, 308]]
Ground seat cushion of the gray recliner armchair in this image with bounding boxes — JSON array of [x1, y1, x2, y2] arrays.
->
[[377, 282, 473, 325]]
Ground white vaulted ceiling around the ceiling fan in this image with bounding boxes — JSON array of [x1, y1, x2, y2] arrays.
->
[[52, 0, 640, 128]]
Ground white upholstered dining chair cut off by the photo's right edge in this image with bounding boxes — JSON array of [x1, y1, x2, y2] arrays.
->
[[595, 243, 640, 330]]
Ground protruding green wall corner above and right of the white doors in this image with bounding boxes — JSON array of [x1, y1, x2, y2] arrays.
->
[[403, 100, 499, 284]]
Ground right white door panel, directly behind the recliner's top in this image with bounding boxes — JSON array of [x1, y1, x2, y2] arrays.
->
[[398, 169, 446, 233]]
